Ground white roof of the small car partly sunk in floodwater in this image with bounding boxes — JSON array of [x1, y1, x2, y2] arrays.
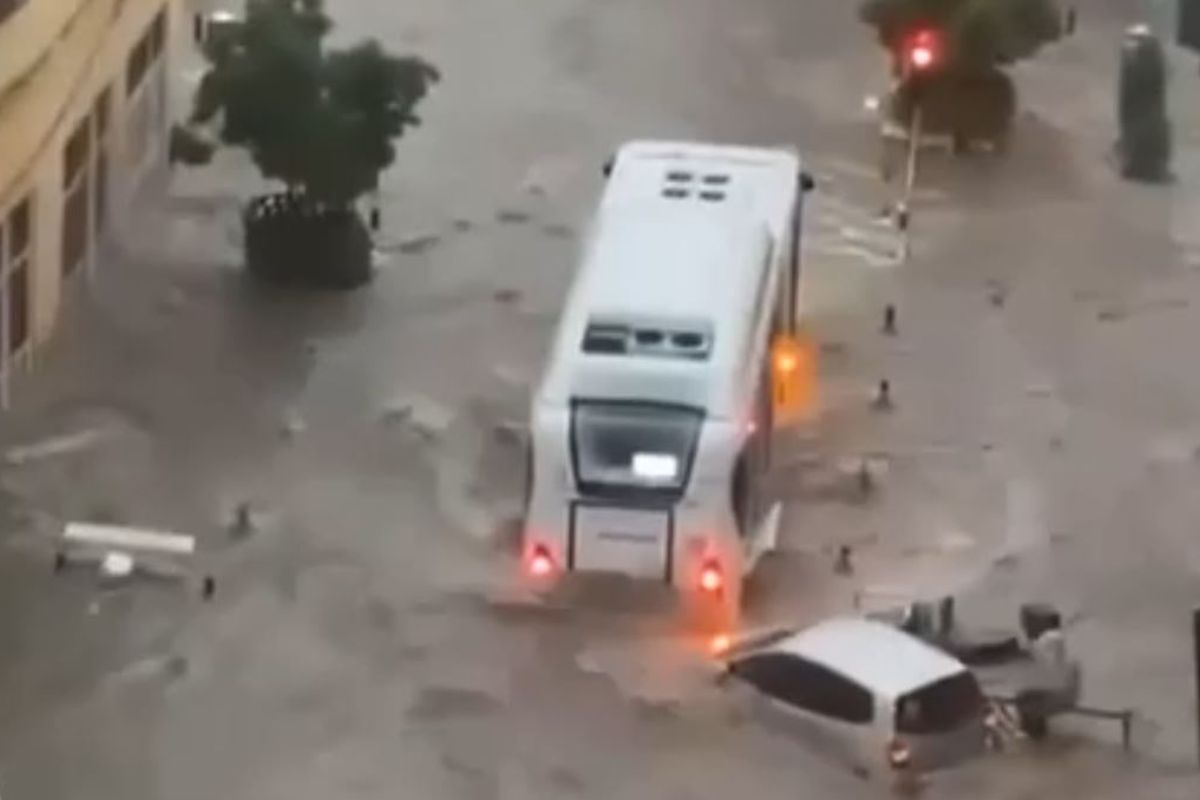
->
[[766, 616, 966, 699]]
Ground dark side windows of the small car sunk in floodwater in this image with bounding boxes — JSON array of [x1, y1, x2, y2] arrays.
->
[[733, 652, 875, 724]]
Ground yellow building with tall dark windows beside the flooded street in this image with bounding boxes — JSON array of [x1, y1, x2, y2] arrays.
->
[[0, 0, 180, 407]]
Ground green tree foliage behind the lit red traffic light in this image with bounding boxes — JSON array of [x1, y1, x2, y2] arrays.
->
[[859, 0, 1063, 72]]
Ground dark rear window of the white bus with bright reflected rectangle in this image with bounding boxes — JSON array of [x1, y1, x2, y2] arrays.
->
[[571, 401, 704, 494]]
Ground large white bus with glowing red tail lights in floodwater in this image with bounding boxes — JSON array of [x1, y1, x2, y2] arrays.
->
[[522, 142, 811, 625]]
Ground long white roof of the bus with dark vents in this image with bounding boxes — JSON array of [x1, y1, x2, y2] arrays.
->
[[540, 142, 799, 416]]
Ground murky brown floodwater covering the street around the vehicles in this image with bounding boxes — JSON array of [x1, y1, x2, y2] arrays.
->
[[0, 0, 1200, 800]]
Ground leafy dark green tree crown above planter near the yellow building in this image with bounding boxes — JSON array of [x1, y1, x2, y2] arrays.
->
[[190, 0, 439, 205]]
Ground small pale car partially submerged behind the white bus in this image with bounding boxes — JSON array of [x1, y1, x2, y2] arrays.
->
[[726, 618, 988, 775]]
